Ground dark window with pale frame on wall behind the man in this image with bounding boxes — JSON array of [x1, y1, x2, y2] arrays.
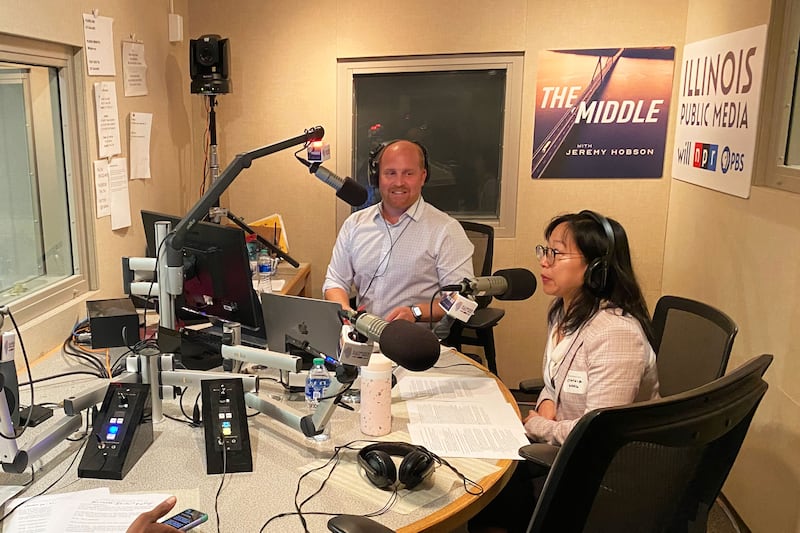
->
[[339, 54, 522, 236]]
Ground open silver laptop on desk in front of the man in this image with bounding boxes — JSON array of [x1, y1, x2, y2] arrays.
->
[[261, 293, 342, 368]]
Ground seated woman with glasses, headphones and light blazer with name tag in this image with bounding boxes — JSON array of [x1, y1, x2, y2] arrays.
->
[[469, 211, 658, 533]]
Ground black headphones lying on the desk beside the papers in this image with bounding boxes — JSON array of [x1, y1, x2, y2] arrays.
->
[[358, 442, 438, 490]]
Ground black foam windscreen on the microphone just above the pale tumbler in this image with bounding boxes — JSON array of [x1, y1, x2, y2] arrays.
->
[[378, 320, 439, 372]]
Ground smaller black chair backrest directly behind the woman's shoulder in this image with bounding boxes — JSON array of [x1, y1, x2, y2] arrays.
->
[[653, 296, 738, 397]]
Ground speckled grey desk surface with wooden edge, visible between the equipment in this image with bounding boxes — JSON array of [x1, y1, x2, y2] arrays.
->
[[0, 344, 515, 533]]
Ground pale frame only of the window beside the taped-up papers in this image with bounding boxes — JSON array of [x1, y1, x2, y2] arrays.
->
[[0, 34, 99, 323]]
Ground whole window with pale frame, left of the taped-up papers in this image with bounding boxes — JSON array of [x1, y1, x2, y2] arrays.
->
[[0, 35, 91, 321]]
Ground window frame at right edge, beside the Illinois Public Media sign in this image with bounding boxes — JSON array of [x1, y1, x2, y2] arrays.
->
[[755, 0, 800, 193]]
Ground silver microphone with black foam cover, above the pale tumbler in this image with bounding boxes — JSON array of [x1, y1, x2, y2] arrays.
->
[[342, 311, 439, 372]]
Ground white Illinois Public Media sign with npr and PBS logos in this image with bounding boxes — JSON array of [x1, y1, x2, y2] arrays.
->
[[672, 25, 767, 198]]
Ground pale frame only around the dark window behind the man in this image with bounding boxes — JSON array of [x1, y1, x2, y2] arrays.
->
[[336, 52, 524, 237]]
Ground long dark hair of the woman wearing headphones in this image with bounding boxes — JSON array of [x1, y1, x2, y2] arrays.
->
[[544, 213, 653, 346]]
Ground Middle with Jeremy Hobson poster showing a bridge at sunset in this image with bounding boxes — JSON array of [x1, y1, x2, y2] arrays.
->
[[531, 46, 675, 178]]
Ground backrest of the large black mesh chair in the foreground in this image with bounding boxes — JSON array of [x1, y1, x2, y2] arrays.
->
[[528, 354, 772, 533]]
